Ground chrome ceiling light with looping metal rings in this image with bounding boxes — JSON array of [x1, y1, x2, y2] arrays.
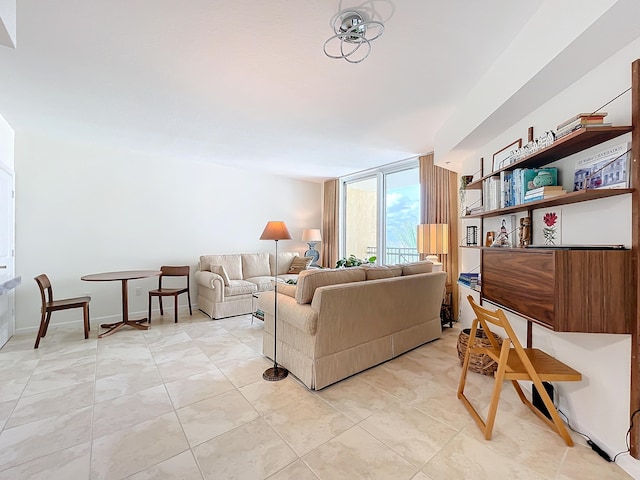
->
[[323, 10, 384, 63]]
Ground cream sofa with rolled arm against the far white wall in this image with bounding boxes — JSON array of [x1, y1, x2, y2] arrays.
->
[[194, 252, 310, 319]]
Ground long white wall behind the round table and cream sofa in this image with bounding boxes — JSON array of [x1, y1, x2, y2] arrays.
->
[[15, 133, 322, 335]]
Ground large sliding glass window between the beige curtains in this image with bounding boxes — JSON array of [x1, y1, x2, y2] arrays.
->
[[340, 159, 420, 264]]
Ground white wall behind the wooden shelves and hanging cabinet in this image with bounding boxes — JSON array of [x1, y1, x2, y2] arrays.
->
[[461, 41, 640, 472]]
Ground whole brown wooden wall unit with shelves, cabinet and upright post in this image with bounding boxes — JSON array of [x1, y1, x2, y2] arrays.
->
[[462, 59, 640, 459]]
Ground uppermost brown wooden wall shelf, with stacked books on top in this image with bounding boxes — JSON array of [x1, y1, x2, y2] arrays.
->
[[467, 126, 632, 190]]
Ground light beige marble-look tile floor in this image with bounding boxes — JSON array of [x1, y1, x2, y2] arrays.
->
[[0, 312, 631, 480]]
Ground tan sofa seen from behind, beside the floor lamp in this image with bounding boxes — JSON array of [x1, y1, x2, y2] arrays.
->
[[258, 262, 446, 390]]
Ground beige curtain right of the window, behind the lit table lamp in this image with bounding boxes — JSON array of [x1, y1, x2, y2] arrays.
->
[[419, 153, 458, 318]]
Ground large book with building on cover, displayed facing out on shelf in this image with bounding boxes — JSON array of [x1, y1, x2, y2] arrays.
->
[[573, 142, 631, 192]]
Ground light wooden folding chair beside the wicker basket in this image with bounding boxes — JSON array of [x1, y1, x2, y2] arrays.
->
[[458, 295, 582, 447]]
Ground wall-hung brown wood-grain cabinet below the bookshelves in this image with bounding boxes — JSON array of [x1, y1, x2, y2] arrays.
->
[[481, 248, 636, 333]]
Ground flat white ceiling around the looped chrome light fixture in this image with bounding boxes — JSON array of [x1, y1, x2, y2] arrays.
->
[[0, 0, 604, 180]]
